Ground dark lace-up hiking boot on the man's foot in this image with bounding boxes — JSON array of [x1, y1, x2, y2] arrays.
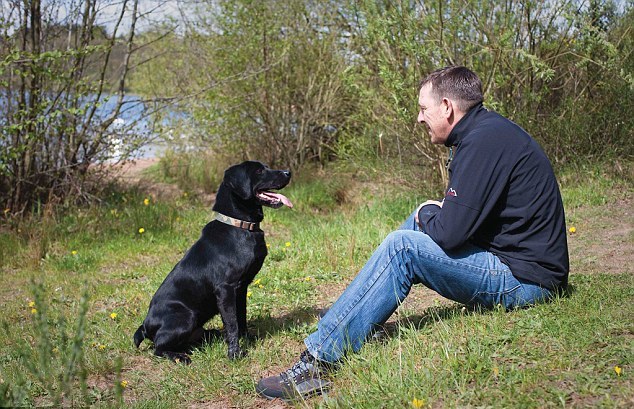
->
[[255, 350, 332, 400]]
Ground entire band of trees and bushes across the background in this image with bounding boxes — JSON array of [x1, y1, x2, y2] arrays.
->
[[0, 0, 634, 214]]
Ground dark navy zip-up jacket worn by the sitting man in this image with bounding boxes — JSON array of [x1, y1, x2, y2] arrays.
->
[[418, 105, 569, 290]]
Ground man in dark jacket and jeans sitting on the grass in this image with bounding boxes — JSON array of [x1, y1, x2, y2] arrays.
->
[[256, 66, 569, 399]]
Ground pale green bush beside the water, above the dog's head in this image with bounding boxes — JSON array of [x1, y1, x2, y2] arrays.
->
[[131, 0, 356, 169]]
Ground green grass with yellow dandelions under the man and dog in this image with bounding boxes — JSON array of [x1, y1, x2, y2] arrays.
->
[[0, 161, 634, 408]]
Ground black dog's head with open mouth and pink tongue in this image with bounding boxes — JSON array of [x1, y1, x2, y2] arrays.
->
[[222, 161, 293, 208]]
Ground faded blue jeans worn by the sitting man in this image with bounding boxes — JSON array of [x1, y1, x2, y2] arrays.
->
[[304, 209, 552, 362]]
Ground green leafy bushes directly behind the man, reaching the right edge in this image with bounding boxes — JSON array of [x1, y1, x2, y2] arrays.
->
[[341, 0, 634, 174]]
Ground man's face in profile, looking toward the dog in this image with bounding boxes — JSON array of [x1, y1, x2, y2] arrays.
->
[[418, 83, 453, 144]]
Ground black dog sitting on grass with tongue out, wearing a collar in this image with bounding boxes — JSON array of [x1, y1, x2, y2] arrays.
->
[[134, 161, 293, 363]]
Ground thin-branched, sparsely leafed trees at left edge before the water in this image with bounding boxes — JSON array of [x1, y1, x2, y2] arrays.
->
[[0, 0, 156, 215]]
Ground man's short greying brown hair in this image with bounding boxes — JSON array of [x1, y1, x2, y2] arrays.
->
[[418, 65, 484, 113]]
